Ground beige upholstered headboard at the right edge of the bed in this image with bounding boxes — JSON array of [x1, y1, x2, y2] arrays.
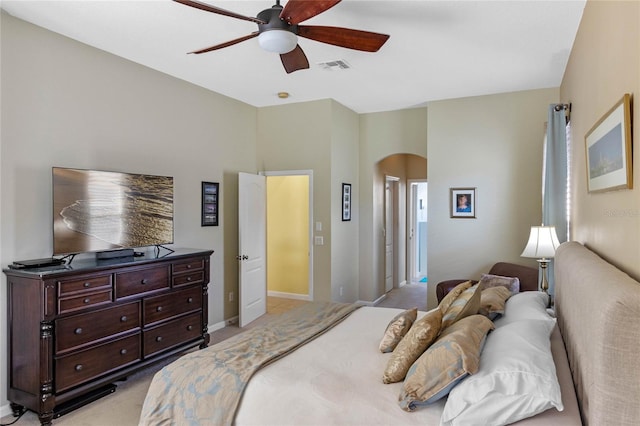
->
[[554, 242, 640, 426]]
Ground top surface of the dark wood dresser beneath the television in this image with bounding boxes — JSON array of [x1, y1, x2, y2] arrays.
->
[[3, 248, 213, 278]]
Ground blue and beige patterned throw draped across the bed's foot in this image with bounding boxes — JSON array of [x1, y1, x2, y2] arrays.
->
[[139, 302, 358, 426]]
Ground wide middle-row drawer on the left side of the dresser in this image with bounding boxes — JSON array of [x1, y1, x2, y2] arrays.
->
[[55, 302, 140, 354]]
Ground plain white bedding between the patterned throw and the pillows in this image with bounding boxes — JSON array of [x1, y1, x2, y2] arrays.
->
[[235, 307, 580, 426]]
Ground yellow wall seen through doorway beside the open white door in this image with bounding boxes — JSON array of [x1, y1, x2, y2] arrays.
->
[[267, 176, 309, 295]]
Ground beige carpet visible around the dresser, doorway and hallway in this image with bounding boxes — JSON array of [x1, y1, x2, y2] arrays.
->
[[1, 284, 427, 426]]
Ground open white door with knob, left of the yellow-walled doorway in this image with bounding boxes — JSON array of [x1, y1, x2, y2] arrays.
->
[[238, 173, 267, 327]]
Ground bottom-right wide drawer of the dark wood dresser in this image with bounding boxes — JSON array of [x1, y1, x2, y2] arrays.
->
[[143, 312, 202, 358]]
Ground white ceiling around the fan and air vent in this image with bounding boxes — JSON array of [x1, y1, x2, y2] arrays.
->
[[0, 0, 585, 113]]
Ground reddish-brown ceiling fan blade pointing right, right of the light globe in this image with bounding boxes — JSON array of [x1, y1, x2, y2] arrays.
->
[[298, 25, 389, 52]]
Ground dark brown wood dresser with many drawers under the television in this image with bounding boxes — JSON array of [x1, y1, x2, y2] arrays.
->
[[4, 249, 213, 425]]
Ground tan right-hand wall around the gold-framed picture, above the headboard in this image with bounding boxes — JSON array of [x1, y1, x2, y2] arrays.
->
[[560, 0, 640, 279]]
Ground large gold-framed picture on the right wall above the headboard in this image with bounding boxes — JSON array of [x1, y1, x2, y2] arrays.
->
[[585, 93, 633, 192]]
